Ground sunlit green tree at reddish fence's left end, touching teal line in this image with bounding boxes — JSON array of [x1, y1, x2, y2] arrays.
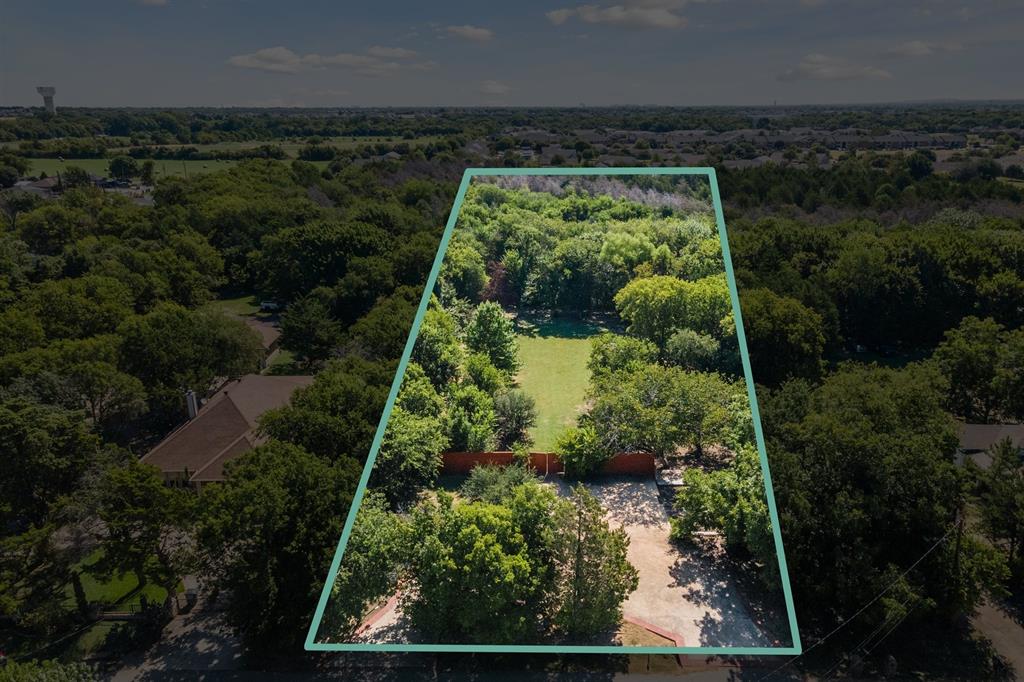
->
[[371, 407, 449, 505]]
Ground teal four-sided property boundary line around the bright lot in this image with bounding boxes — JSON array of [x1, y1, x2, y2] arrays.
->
[[305, 167, 803, 655]]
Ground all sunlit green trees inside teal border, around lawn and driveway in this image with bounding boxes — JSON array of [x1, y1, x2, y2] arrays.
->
[[318, 176, 779, 643]]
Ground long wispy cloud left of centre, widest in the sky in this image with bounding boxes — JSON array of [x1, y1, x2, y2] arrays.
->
[[227, 45, 437, 76]]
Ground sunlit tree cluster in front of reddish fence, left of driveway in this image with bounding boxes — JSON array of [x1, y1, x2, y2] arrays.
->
[[324, 466, 638, 643]]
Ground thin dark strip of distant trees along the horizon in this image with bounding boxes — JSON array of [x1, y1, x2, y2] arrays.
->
[[0, 103, 1024, 144]]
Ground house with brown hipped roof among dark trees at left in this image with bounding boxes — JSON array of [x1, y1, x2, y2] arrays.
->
[[142, 374, 313, 488]]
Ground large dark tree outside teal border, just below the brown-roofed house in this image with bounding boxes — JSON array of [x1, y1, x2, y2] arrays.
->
[[197, 441, 359, 653]]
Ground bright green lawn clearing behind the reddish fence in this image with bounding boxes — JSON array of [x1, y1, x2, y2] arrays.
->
[[517, 317, 604, 452]]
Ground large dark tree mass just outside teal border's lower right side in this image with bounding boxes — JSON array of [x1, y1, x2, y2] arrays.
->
[[761, 365, 981, 627]]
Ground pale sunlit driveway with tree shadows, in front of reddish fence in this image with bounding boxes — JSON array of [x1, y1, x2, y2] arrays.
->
[[573, 477, 773, 646]]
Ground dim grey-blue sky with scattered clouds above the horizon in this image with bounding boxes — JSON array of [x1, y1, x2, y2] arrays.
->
[[6, 0, 1024, 106]]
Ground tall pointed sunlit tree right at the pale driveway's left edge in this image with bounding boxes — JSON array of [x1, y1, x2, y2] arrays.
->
[[551, 484, 639, 641]]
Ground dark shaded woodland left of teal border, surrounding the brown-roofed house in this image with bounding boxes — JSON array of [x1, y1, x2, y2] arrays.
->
[[0, 156, 451, 652]]
